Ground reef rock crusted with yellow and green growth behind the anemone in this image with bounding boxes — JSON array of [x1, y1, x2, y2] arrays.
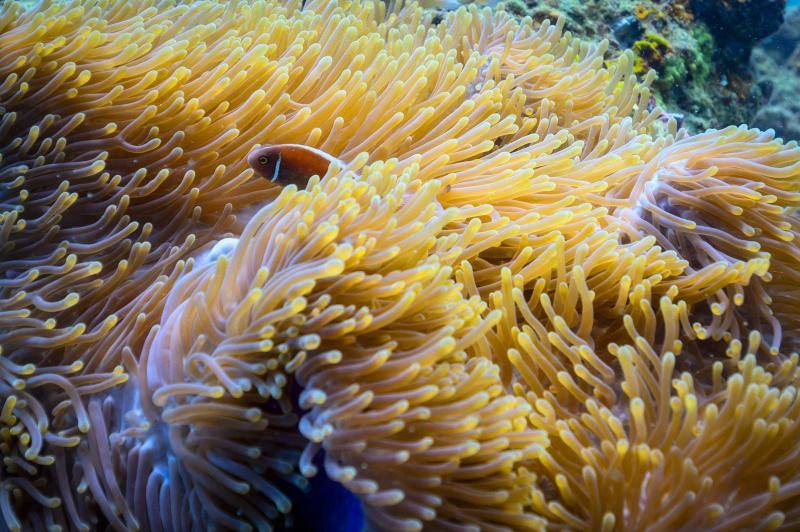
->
[[501, 0, 785, 131]]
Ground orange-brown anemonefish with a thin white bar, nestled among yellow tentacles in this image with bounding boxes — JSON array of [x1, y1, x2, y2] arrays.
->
[[247, 144, 345, 188]]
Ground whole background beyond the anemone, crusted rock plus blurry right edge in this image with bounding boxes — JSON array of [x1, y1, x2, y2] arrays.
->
[[482, 0, 800, 139]]
